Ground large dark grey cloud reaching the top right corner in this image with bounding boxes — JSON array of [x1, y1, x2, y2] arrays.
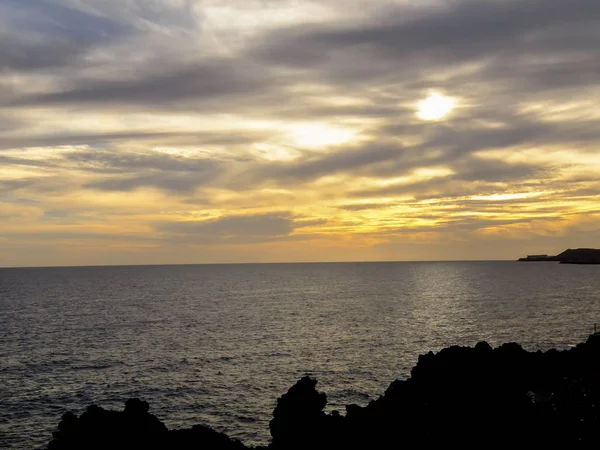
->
[[257, 0, 600, 74]]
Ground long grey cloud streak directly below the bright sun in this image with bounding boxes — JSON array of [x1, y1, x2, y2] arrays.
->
[[248, 117, 560, 189]]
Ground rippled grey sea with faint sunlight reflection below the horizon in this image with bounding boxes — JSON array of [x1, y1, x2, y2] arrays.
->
[[0, 262, 600, 449]]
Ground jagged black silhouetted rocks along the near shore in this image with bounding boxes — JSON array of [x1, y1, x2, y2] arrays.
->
[[48, 334, 600, 450]]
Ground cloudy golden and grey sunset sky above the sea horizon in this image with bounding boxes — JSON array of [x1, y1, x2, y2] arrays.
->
[[0, 0, 600, 266]]
